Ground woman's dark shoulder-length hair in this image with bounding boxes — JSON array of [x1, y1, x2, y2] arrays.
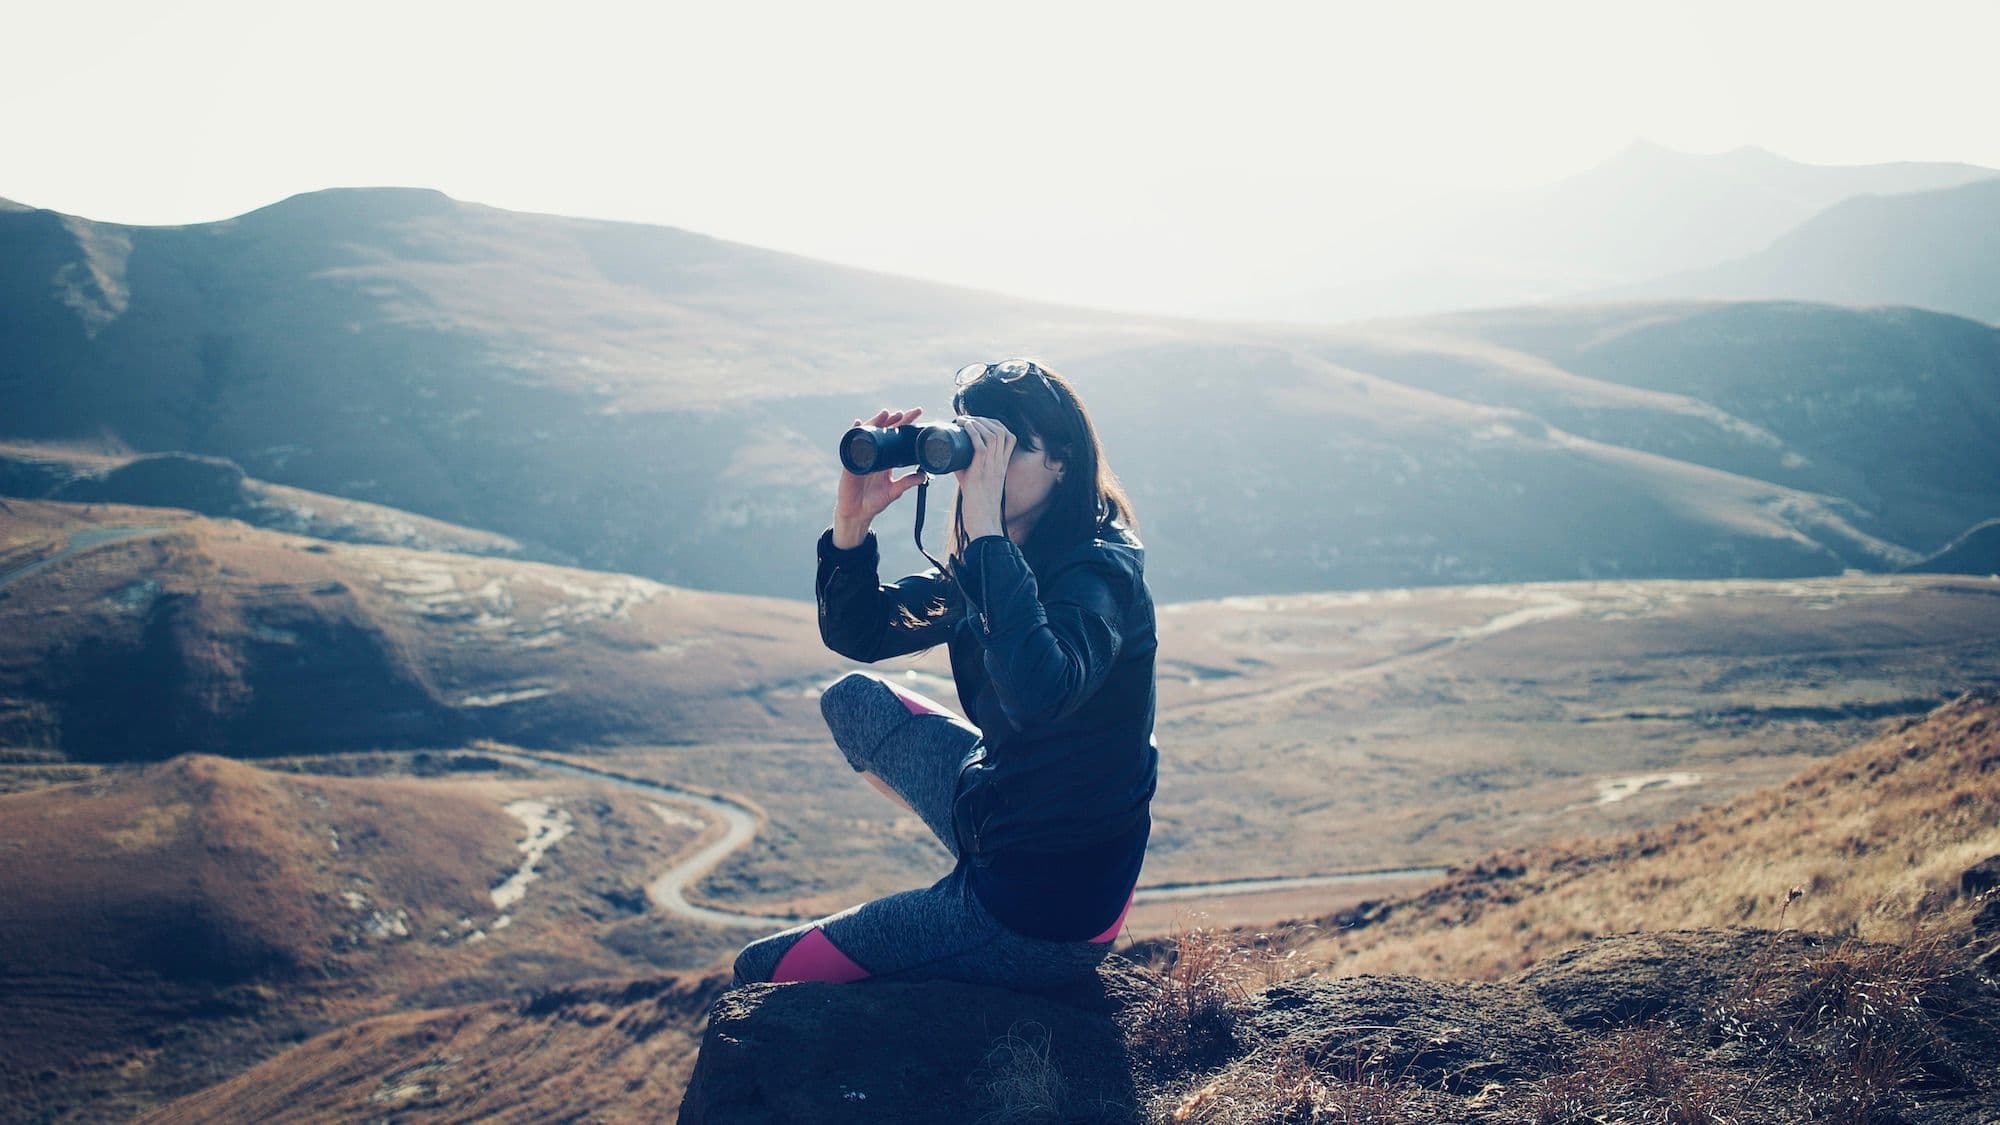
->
[[952, 356, 1138, 573]]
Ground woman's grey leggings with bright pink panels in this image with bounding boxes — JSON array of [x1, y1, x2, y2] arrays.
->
[[736, 673, 1122, 989]]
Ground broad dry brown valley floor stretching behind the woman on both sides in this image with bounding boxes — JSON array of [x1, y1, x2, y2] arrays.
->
[[0, 502, 2000, 912]]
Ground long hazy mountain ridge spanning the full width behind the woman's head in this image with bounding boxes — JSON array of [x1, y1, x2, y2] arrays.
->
[[0, 190, 2000, 601]]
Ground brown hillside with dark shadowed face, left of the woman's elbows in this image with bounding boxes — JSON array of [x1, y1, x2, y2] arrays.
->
[[0, 500, 840, 761]]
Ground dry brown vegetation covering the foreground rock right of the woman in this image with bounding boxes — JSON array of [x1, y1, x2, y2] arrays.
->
[[1120, 903, 2000, 1125]]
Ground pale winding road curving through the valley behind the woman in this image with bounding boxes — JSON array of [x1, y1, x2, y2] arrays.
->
[[480, 749, 1444, 929]]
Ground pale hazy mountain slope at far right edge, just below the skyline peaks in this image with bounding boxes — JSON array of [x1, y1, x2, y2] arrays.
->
[[1592, 178, 2000, 322]]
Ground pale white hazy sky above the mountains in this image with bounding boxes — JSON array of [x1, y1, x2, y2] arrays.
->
[[0, 0, 2000, 304]]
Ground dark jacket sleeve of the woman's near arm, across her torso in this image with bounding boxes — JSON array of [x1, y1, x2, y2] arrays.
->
[[964, 534, 1130, 731]]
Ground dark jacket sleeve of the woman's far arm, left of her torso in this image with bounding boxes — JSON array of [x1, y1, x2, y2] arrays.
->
[[814, 528, 962, 665]]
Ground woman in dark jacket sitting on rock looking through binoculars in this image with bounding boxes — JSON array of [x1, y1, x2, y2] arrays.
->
[[736, 360, 1158, 989]]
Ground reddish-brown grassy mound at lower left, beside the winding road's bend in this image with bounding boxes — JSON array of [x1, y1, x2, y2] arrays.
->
[[0, 755, 726, 1121]]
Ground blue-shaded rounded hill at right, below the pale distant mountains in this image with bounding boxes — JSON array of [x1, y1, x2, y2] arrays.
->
[[1332, 302, 2000, 554]]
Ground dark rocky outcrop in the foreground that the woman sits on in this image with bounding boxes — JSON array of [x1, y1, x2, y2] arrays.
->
[[680, 931, 2000, 1125]]
